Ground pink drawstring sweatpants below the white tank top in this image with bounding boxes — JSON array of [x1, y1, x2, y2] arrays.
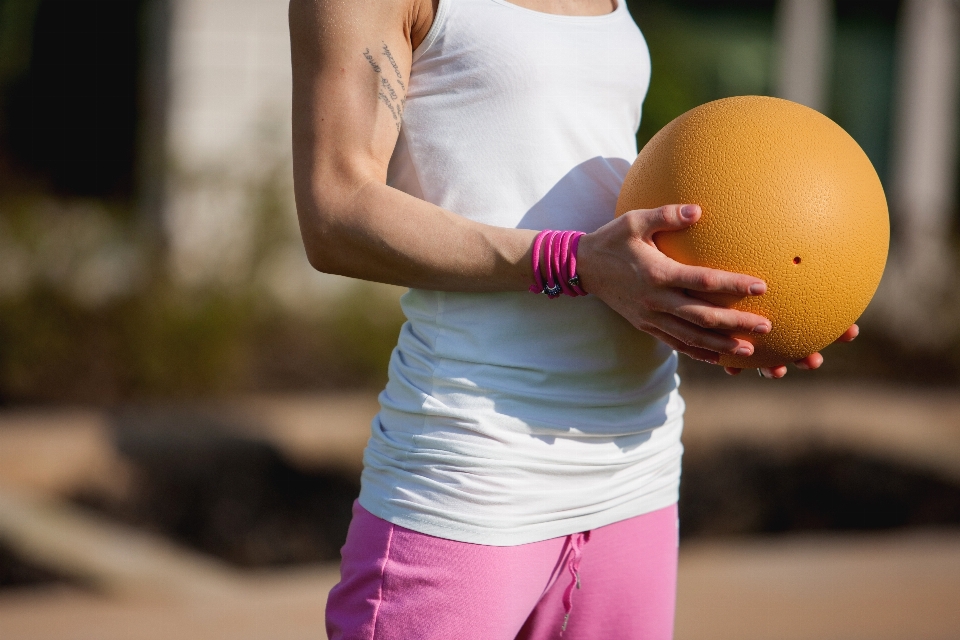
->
[[327, 504, 677, 640]]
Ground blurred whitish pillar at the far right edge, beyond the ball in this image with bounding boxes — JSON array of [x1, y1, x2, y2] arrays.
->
[[878, 0, 960, 347]]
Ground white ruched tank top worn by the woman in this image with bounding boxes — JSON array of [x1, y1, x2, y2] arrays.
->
[[360, 0, 683, 545]]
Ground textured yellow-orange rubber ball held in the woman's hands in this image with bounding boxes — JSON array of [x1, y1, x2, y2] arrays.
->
[[617, 96, 890, 368]]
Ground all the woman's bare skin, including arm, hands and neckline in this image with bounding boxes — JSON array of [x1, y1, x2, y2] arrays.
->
[[290, 0, 857, 378]]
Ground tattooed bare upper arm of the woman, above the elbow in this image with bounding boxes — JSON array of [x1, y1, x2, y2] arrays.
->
[[289, 0, 433, 201]]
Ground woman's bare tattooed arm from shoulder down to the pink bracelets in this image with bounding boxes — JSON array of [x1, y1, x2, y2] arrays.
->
[[290, 0, 536, 291]]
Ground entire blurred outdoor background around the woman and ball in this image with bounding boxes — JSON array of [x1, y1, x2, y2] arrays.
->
[[0, 0, 960, 640]]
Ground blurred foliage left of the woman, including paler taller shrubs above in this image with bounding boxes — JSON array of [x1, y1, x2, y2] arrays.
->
[[0, 174, 403, 405]]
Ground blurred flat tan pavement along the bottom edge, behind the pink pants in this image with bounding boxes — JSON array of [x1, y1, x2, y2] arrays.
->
[[0, 534, 960, 640]]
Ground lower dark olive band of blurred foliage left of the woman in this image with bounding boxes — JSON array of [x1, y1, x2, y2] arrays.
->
[[0, 262, 402, 404]]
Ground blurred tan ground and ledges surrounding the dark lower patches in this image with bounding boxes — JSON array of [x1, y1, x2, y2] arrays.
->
[[0, 380, 960, 640]]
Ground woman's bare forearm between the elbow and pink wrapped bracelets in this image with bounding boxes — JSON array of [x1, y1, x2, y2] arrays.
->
[[297, 180, 537, 292]]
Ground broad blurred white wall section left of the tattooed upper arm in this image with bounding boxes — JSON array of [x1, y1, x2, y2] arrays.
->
[[162, 0, 356, 306]]
